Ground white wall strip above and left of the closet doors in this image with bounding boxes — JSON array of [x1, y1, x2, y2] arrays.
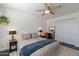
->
[[46, 12, 79, 31]]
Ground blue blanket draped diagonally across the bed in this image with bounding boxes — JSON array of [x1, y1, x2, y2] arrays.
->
[[19, 39, 55, 56]]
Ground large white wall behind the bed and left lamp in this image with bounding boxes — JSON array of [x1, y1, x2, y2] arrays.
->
[[0, 8, 46, 51]]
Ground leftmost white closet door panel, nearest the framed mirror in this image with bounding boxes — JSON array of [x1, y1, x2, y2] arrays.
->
[[55, 21, 64, 42]]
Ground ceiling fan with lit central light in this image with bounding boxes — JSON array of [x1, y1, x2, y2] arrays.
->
[[36, 3, 62, 16]]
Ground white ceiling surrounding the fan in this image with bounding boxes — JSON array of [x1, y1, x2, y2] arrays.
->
[[0, 3, 79, 19]]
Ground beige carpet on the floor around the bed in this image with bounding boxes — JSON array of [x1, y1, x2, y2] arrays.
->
[[10, 46, 79, 56]]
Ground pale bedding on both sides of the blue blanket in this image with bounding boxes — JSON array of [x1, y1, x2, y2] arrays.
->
[[19, 38, 59, 56]]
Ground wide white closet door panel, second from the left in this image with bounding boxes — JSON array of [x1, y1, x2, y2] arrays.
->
[[63, 20, 76, 45]]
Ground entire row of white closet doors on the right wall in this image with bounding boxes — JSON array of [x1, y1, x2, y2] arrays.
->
[[56, 19, 79, 47]]
